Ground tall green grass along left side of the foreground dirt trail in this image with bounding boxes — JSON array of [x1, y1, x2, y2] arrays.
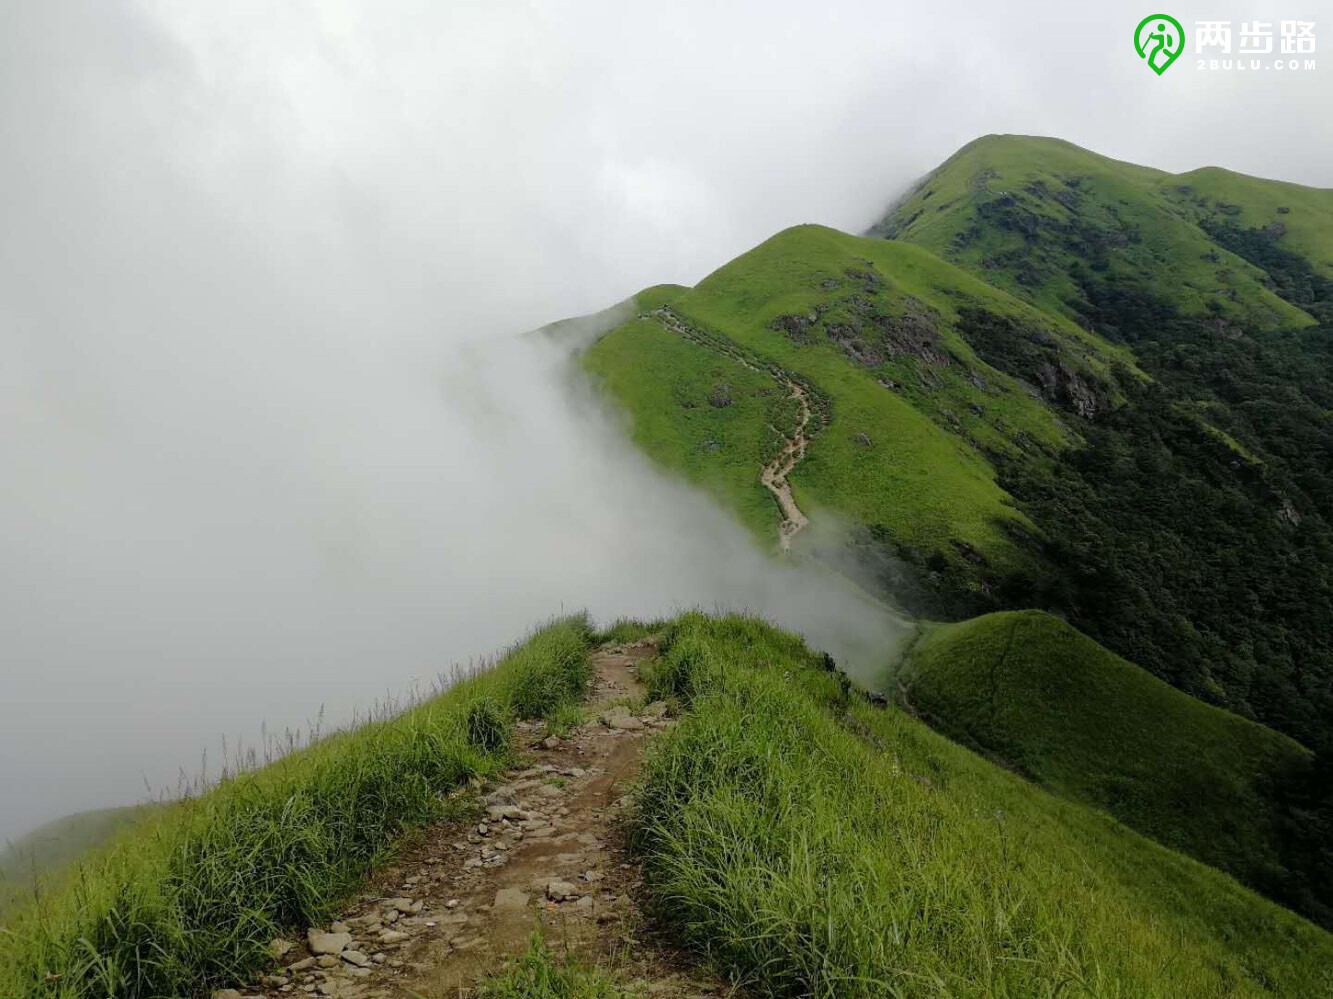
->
[[0, 615, 591, 999]]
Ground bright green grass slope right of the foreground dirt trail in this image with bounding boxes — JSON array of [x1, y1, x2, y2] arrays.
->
[[632, 615, 1333, 998]]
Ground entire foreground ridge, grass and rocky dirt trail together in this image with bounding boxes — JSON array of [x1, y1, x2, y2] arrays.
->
[[10, 614, 1333, 999]]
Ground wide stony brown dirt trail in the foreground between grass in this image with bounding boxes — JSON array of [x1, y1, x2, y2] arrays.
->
[[231, 644, 732, 999]]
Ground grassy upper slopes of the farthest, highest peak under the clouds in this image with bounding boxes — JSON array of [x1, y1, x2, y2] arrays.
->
[[873, 135, 1311, 325]]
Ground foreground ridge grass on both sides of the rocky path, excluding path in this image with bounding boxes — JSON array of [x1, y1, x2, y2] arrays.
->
[[10, 614, 1333, 999]]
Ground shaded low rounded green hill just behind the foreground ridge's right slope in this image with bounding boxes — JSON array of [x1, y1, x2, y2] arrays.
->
[[898, 611, 1318, 910]]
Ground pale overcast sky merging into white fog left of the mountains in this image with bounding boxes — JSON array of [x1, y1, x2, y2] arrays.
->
[[0, 0, 1333, 838]]
